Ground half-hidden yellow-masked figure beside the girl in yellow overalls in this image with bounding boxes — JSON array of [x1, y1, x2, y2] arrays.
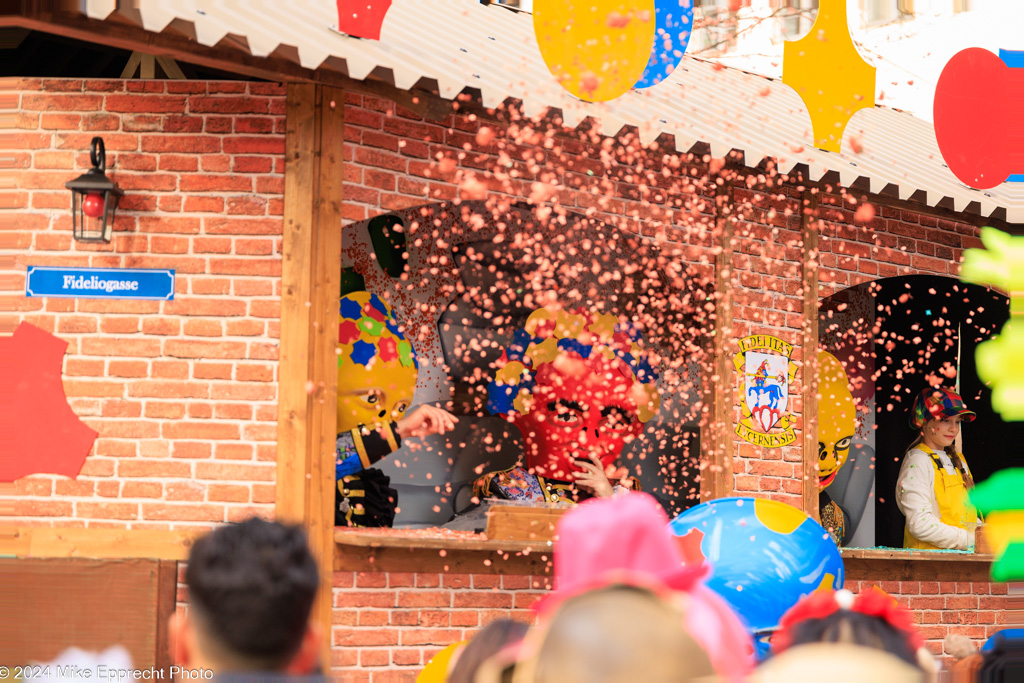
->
[[818, 350, 856, 547]]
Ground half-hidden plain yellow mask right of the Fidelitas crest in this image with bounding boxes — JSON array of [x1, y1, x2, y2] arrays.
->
[[818, 350, 856, 488]]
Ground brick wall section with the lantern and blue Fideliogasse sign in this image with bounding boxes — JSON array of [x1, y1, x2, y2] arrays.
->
[[0, 80, 285, 528]]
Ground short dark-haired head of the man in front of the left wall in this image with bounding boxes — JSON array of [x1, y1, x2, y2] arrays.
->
[[172, 518, 319, 671]]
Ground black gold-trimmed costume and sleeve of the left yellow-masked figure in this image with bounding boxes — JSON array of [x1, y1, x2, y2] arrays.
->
[[334, 422, 401, 526]]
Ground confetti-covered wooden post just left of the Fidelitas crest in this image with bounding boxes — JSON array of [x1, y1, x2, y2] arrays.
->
[[700, 178, 736, 501]]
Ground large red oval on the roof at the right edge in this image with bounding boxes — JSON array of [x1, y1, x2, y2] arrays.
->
[[934, 47, 1024, 189]]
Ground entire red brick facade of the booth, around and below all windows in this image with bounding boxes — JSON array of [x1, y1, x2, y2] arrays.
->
[[0, 80, 1007, 681]]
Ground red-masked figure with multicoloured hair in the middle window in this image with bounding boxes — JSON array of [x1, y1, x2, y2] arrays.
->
[[473, 308, 660, 503]]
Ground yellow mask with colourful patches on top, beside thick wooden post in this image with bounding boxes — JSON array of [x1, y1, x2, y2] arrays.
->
[[338, 292, 419, 432]]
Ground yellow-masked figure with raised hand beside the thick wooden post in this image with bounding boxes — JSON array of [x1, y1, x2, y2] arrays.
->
[[335, 292, 458, 526]]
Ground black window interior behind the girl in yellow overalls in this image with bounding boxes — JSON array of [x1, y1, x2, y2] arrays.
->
[[819, 275, 1024, 548]]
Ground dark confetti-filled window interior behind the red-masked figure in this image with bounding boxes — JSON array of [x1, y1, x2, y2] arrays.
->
[[354, 202, 708, 526]]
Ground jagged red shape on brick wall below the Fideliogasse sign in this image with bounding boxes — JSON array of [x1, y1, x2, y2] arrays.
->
[[0, 323, 98, 482]]
